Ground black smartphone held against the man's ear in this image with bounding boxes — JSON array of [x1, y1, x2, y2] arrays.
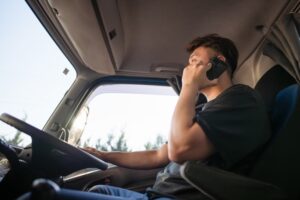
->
[[206, 57, 228, 80]]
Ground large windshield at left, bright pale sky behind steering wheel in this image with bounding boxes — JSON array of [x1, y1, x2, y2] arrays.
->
[[0, 0, 76, 146]]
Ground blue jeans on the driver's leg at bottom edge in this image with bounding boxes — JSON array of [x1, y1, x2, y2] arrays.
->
[[89, 185, 171, 200]]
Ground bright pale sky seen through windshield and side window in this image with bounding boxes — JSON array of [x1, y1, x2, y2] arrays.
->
[[0, 0, 177, 149]]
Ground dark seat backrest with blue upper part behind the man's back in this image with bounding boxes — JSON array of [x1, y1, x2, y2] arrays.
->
[[250, 84, 300, 199]]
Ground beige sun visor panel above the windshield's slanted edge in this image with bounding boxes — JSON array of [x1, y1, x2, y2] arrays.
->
[[48, 0, 115, 74]]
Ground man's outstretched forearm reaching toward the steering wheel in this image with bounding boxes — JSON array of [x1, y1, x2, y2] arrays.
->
[[84, 144, 169, 169]]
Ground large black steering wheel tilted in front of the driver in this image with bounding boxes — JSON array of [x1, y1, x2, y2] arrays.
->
[[0, 113, 108, 177]]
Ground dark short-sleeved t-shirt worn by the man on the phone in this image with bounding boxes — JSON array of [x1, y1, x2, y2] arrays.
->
[[148, 84, 270, 199]]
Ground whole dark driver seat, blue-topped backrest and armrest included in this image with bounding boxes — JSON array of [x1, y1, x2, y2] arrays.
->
[[181, 84, 300, 200]]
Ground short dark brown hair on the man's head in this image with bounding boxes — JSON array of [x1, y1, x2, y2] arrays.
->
[[186, 34, 239, 73]]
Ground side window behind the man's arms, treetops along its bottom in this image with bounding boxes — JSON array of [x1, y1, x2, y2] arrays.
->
[[69, 84, 178, 151]]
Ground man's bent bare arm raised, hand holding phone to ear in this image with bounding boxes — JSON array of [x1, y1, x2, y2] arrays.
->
[[168, 63, 214, 163]]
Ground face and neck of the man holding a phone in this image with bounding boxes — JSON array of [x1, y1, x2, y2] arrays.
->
[[189, 47, 219, 90]]
